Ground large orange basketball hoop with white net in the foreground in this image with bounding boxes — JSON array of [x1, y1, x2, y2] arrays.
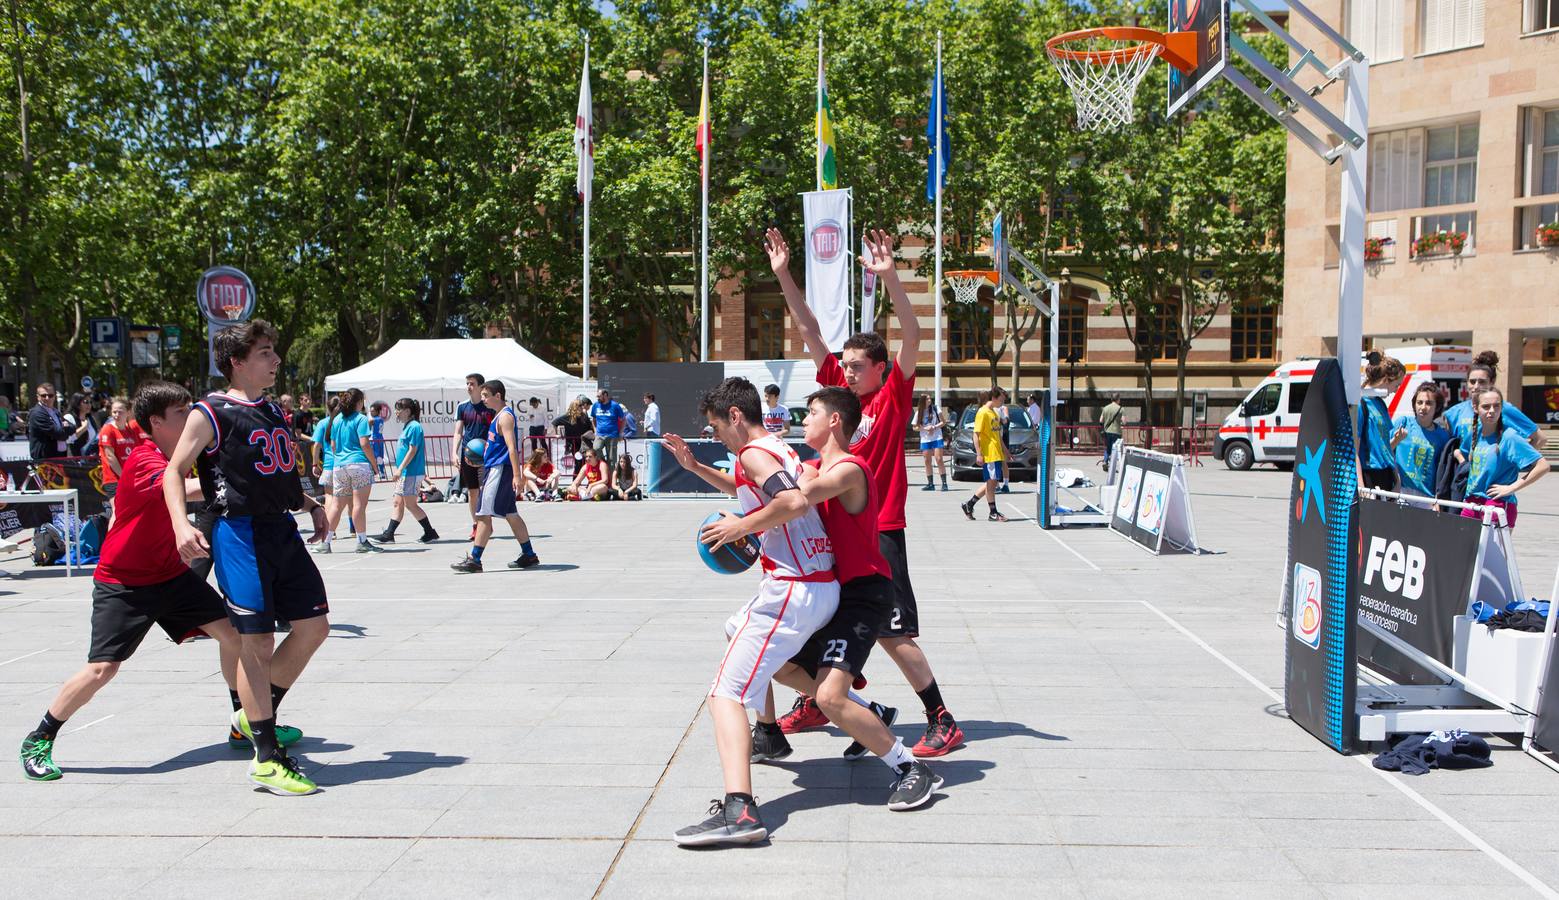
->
[[1045, 28, 1197, 131]]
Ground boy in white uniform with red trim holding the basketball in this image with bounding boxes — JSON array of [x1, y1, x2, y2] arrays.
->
[[666, 377, 839, 847]]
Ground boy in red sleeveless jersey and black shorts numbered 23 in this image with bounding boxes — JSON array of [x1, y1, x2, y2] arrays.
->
[[702, 387, 942, 811]]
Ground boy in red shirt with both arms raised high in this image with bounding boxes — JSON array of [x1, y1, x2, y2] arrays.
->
[[764, 228, 963, 756]]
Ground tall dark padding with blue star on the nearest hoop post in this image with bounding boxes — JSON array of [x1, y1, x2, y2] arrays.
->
[[1283, 359, 1358, 753]]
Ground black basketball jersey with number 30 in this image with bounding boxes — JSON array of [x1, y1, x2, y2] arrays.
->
[[190, 393, 302, 518]]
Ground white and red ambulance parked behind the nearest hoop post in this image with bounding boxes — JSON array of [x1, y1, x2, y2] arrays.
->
[[1213, 345, 1472, 471]]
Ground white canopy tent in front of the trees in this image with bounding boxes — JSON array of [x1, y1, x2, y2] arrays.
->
[[324, 338, 594, 438]]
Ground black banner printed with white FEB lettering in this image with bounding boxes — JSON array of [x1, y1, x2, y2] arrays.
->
[[1356, 499, 1484, 685]]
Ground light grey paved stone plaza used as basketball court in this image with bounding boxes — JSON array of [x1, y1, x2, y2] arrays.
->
[[0, 463, 1559, 898]]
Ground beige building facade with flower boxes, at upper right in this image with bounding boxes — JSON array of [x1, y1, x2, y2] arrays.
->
[[1283, 0, 1559, 406]]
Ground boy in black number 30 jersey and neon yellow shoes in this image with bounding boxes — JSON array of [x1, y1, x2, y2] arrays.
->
[[162, 318, 331, 795]]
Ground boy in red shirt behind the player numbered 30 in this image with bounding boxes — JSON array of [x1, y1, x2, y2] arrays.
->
[[22, 381, 302, 781]]
